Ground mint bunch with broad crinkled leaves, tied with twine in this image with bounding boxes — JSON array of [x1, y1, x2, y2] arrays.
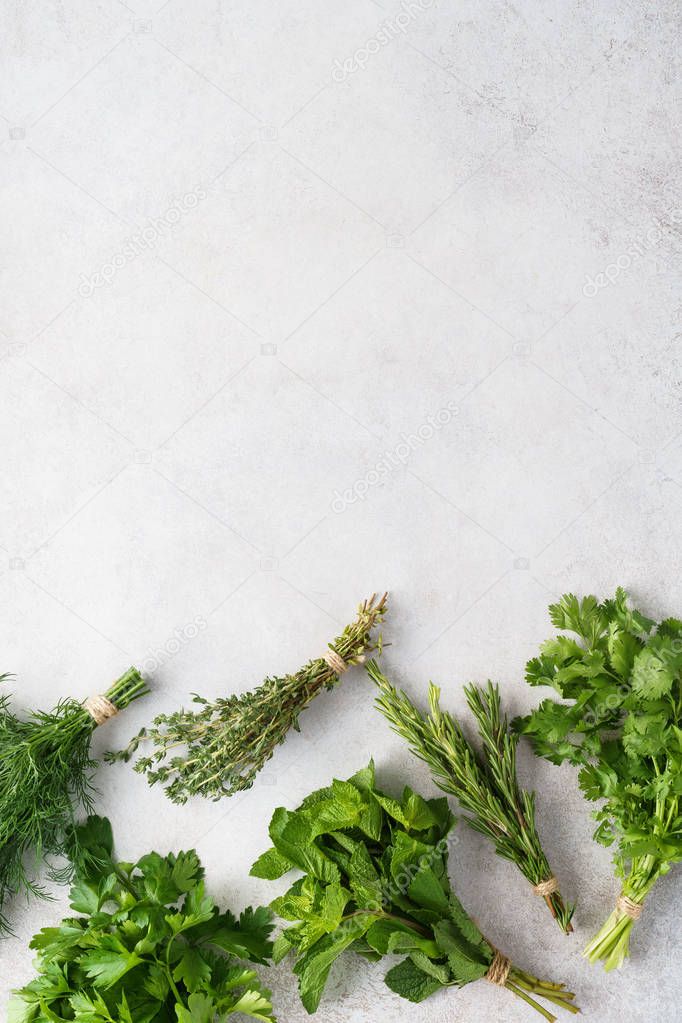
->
[[252, 762, 579, 1020]]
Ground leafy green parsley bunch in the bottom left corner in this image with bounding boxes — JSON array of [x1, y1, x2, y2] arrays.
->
[[9, 817, 274, 1023]]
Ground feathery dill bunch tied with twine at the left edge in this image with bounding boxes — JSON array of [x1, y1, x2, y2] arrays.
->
[[0, 668, 147, 931]]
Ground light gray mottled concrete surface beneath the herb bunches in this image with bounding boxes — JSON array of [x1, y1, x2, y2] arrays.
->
[[0, 0, 682, 1023]]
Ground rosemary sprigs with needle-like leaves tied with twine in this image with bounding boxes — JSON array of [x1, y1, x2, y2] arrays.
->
[[367, 661, 574, 932]]
